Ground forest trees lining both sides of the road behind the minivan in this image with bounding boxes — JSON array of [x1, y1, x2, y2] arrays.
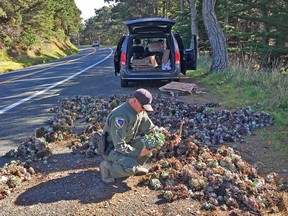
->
[[0, 0, 288, 70]]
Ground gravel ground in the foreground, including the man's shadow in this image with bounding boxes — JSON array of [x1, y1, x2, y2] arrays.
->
[[0, 142, 204, 216]]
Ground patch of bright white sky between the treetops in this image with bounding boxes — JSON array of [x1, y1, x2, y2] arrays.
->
[[75, 0, 108, 21]]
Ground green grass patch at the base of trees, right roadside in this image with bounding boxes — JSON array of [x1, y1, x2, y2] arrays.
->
[[187, 57, 288, 154]]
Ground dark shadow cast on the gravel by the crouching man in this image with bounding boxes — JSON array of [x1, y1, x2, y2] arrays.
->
[[15, 170, 131, 206]]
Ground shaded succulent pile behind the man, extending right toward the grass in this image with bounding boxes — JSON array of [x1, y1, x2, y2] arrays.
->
[[152, 98, 273, 145]]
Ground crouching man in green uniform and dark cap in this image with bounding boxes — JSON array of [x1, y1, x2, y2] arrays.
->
[[100, 89, 161, 183]]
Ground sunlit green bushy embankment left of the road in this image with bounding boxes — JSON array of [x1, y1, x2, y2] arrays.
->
[[0, 0, 82, 74]]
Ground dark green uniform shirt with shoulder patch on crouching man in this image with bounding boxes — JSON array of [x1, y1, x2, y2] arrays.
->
[[104, 102, 155, 157]]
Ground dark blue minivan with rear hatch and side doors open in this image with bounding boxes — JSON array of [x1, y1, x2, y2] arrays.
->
[[114, 18, 197, 87]]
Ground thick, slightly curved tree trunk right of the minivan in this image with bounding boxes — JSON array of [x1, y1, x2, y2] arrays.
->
[[202, 0, 228, 72]]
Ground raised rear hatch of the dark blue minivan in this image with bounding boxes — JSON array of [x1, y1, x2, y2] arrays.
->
[[125, 18, 176, 34]]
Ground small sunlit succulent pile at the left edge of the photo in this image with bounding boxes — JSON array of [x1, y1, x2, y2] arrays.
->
[[0, 161, 35, 200]]
